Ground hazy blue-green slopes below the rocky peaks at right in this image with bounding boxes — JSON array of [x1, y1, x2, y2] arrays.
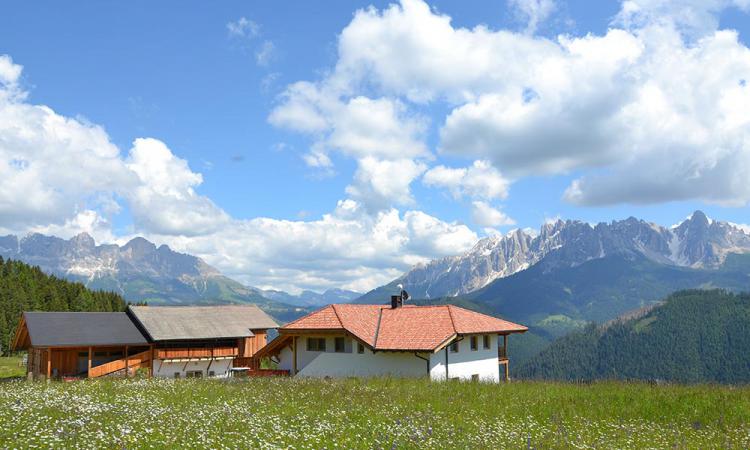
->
[[465, 254, 750, 337]]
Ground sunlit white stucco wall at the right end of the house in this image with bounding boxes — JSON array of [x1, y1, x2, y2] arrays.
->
[[430, 335, 500, 383]]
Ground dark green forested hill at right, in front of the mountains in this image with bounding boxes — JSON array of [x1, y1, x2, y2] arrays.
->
[[516, 290, 750, 383]]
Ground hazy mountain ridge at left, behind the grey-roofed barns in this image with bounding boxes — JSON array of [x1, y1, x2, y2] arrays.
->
[[0, 233, 310, 321]]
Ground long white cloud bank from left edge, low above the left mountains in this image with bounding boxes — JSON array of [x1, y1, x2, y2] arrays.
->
[[0, 53, 477, 291]]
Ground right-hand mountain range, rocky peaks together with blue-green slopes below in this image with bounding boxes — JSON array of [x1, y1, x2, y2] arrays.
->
[[354, 211, 750, 366]]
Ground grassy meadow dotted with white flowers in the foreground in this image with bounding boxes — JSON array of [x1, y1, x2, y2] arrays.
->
[[0, 378, 750, 449]]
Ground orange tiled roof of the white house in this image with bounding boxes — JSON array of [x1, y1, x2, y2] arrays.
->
[[279, 304, 528, 351]]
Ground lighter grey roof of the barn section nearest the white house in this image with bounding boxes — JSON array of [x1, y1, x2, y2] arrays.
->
[[129, 305, 278, 341]]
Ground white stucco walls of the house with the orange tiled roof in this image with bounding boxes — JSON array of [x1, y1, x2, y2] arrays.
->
[[279, 335, 500, 382]]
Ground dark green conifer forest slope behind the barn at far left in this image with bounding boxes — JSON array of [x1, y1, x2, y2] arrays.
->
[[0, 257, 126, 352]]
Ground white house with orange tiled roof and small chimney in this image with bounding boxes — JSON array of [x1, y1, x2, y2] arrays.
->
[[258, 296, 527, 382]]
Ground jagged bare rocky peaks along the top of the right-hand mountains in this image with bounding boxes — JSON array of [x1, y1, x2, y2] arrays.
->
[[356, 211, 750, 303]]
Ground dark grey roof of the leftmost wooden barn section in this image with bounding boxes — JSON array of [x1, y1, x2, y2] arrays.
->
[[24, 312, 148, 347]]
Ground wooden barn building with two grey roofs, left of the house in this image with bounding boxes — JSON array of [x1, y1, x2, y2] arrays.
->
[[12, 305, 277, 378]]
